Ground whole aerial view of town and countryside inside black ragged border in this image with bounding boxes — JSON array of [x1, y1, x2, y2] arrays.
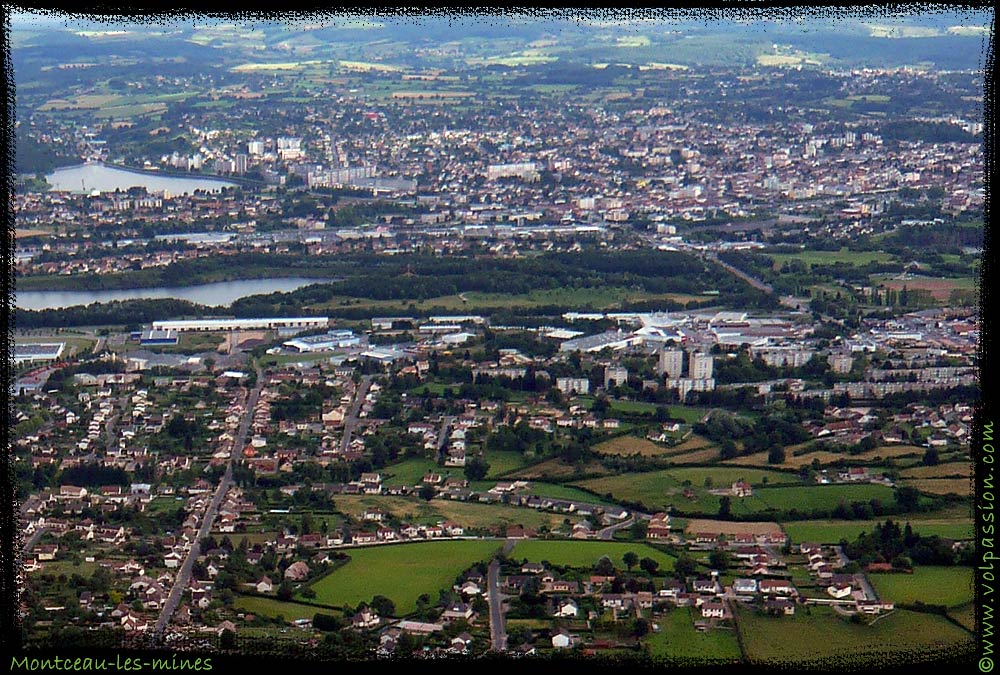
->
[[10, 10, 986, 666]]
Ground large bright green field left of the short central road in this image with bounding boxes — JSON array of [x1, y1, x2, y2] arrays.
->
[[298, 541, 500, 615]]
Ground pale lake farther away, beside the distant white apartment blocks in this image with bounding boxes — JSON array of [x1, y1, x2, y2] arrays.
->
[[45, 163, 236, 195]]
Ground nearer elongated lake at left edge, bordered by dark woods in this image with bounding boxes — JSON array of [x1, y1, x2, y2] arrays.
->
[[14, 277, 332, 310]]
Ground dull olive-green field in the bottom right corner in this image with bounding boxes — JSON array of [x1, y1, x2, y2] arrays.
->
[[739, 607, 975, 670]]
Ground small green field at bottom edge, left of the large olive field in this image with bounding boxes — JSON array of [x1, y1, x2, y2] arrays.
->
[[643, 607, 740, 662]]
